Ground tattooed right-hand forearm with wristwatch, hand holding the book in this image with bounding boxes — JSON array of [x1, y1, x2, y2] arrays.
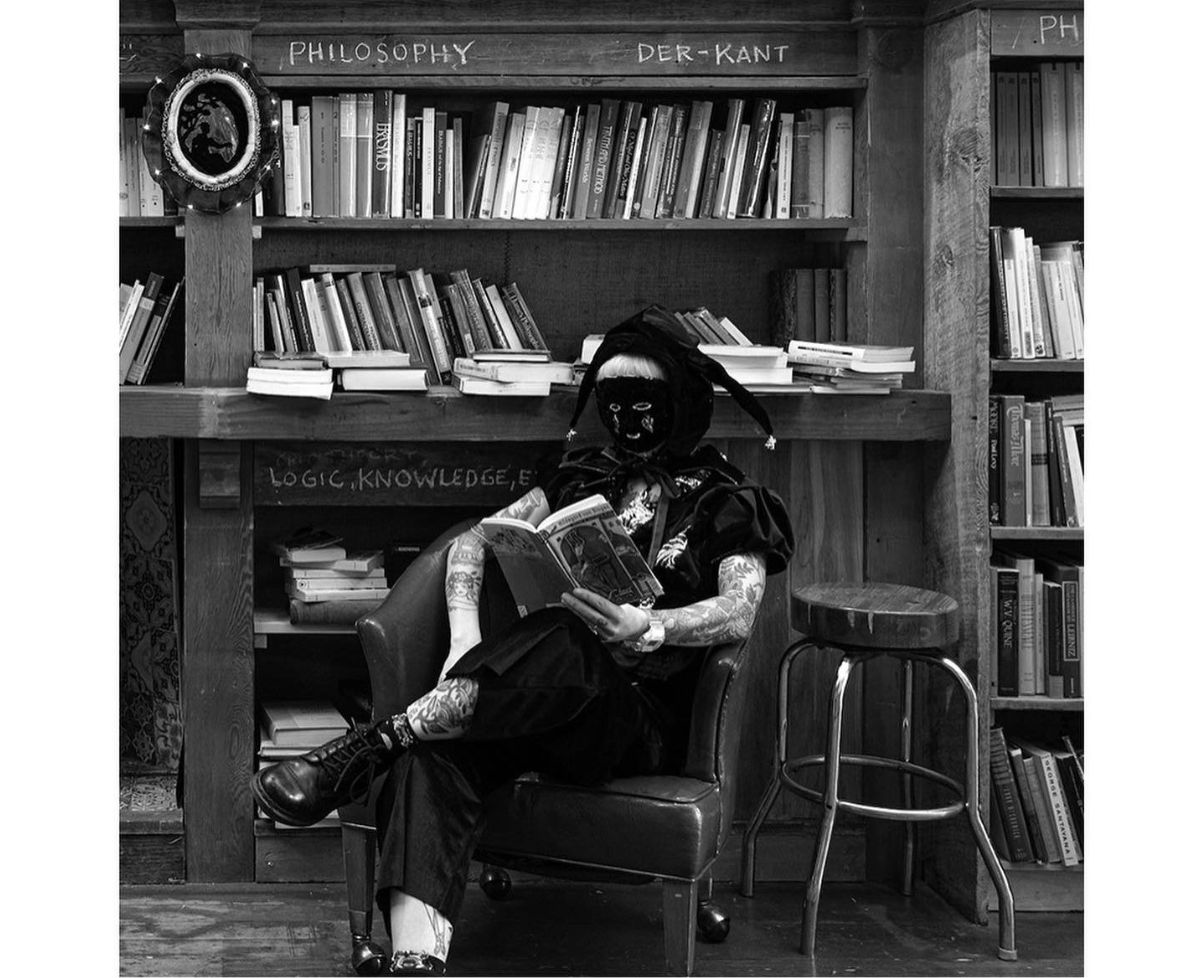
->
[[563, 553, 767, 660]]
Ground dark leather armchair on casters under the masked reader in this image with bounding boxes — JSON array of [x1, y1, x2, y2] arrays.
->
[[341, 524, 746, 974]]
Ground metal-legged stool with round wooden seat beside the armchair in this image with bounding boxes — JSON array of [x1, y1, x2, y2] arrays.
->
[[742, 583, 1016, 961]]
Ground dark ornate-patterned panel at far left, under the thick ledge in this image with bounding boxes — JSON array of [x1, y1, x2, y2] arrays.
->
[[120, 438, 182, 772]]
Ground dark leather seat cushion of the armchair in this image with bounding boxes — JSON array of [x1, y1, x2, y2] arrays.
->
[[479, 774, 721, 880]]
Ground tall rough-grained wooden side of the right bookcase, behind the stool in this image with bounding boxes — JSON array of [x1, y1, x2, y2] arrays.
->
[[922, 12, 991, 920]]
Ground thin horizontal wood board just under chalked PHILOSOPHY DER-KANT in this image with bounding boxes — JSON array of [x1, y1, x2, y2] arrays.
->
[[262, 74, 866, 96]]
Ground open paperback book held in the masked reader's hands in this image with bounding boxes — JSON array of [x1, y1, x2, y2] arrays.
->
[[479, 493, 662, 616]]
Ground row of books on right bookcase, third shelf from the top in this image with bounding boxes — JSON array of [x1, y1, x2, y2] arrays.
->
[[988, 394, 1084, 527]]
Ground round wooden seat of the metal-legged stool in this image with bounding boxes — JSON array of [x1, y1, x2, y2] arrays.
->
[[792, 581, 960, 652]]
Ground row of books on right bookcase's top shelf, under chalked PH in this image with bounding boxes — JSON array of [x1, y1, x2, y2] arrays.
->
[[991, 61, 1084, 187]]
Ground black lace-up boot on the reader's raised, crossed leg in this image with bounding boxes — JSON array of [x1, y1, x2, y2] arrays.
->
[[251, 714, 413, 826]]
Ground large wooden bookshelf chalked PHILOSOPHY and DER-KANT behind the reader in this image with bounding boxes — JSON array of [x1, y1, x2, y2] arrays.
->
[[119, 0, 936, 882]]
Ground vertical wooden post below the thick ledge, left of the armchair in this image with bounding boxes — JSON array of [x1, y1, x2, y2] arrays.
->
[[180, 444, 254, 882]]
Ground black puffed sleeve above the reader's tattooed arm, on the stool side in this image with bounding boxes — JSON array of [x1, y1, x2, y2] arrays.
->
[[695, 482, 796, 574]]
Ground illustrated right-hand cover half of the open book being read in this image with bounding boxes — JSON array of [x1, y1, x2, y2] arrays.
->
[[538, 494, 662, 605]]
